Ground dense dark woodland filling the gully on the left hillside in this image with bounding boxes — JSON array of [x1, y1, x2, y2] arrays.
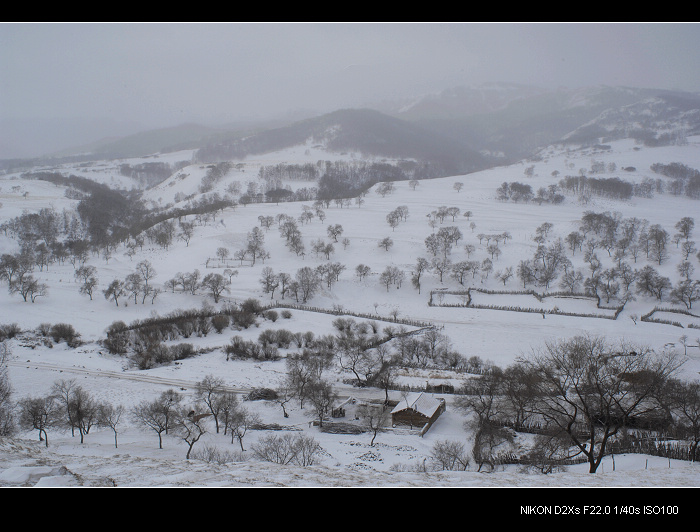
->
[[0, 178, 243, 302]]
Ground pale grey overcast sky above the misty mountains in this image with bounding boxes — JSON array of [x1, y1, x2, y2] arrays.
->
[[0, 23, 700, 156]]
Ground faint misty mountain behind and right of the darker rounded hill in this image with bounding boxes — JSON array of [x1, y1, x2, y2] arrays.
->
[[396, 85, 700, 162]]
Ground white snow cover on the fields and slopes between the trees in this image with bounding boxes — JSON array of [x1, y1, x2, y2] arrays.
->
[[0, 137, 700, 487]]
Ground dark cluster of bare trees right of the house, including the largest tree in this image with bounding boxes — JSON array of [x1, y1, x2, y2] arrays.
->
[[448, 336, 700, 473]]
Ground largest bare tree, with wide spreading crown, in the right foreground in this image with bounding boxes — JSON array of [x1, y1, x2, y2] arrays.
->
[[526, 336, 680, 473]]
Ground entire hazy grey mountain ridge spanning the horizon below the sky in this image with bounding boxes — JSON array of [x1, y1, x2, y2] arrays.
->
[[6, 83, 700, 175]]
